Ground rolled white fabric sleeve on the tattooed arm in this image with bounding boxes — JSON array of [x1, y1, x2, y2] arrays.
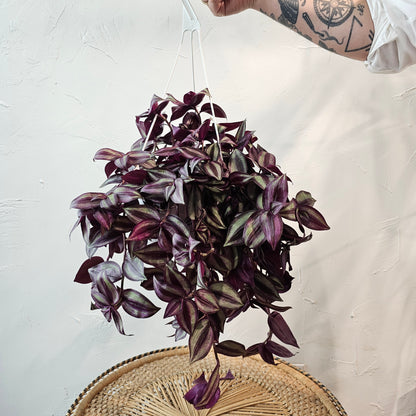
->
[[365, 0, 416, 73]]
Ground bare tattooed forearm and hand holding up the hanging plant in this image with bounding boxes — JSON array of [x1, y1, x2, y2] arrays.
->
[[203, 0, 374, 61]]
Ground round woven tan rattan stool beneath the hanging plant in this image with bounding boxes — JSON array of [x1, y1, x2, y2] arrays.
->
[[67, 347, 346, 416]]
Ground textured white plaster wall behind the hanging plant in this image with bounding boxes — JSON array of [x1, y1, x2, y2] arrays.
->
[[0, 0, 416, 416]]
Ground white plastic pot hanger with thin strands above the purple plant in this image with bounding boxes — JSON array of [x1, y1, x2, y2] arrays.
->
[[143, 0, 222, 159]]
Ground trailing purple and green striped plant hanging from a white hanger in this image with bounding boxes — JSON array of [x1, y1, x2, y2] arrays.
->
[[71, 90, 329, 409]]
